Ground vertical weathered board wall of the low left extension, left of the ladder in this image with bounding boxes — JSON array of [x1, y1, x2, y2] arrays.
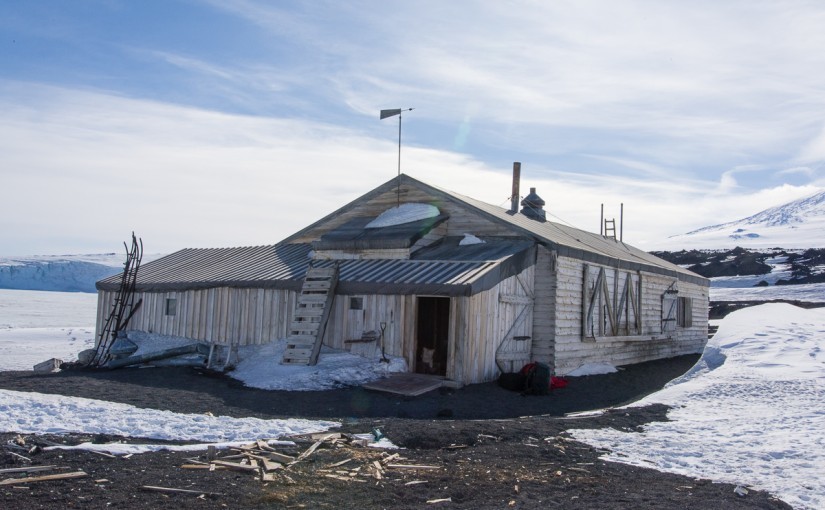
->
[[97, 287, 296, 345]]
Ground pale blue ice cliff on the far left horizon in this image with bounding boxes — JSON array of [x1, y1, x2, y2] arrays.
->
[[0, 253, 158, 292]]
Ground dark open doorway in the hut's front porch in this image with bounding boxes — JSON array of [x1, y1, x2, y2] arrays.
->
[[415, 297, 450, 375]]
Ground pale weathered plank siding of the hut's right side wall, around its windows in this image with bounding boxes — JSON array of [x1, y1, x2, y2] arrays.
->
[[555, 257, 708, 375]]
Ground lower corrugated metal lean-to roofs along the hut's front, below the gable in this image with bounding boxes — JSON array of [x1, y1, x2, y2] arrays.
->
[[97, 242, 535, 295]]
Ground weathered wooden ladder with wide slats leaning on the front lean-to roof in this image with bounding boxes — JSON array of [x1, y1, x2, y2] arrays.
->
[[281, 263, 338, 365]]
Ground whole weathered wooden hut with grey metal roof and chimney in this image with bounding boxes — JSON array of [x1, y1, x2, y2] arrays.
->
[[97, 172, 709, 384]]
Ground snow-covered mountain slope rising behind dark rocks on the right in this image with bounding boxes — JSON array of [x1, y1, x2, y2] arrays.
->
[[657, 191, 825, 251]]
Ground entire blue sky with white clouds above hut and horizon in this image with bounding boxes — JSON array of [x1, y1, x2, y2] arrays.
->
[[0, 0, 825, 255]]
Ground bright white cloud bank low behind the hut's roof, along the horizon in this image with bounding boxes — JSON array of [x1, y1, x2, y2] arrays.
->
[[0, 82, 811, 254]]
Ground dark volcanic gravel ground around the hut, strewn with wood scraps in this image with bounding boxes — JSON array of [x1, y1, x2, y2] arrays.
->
[[0, 356, 790, 509]]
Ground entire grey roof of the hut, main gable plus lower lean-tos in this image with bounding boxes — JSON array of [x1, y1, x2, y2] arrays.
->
[[98, 174, 709, 295]]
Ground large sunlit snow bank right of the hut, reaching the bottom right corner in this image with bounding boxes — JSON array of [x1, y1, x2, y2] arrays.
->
[[570, 304, 825, 509]]
